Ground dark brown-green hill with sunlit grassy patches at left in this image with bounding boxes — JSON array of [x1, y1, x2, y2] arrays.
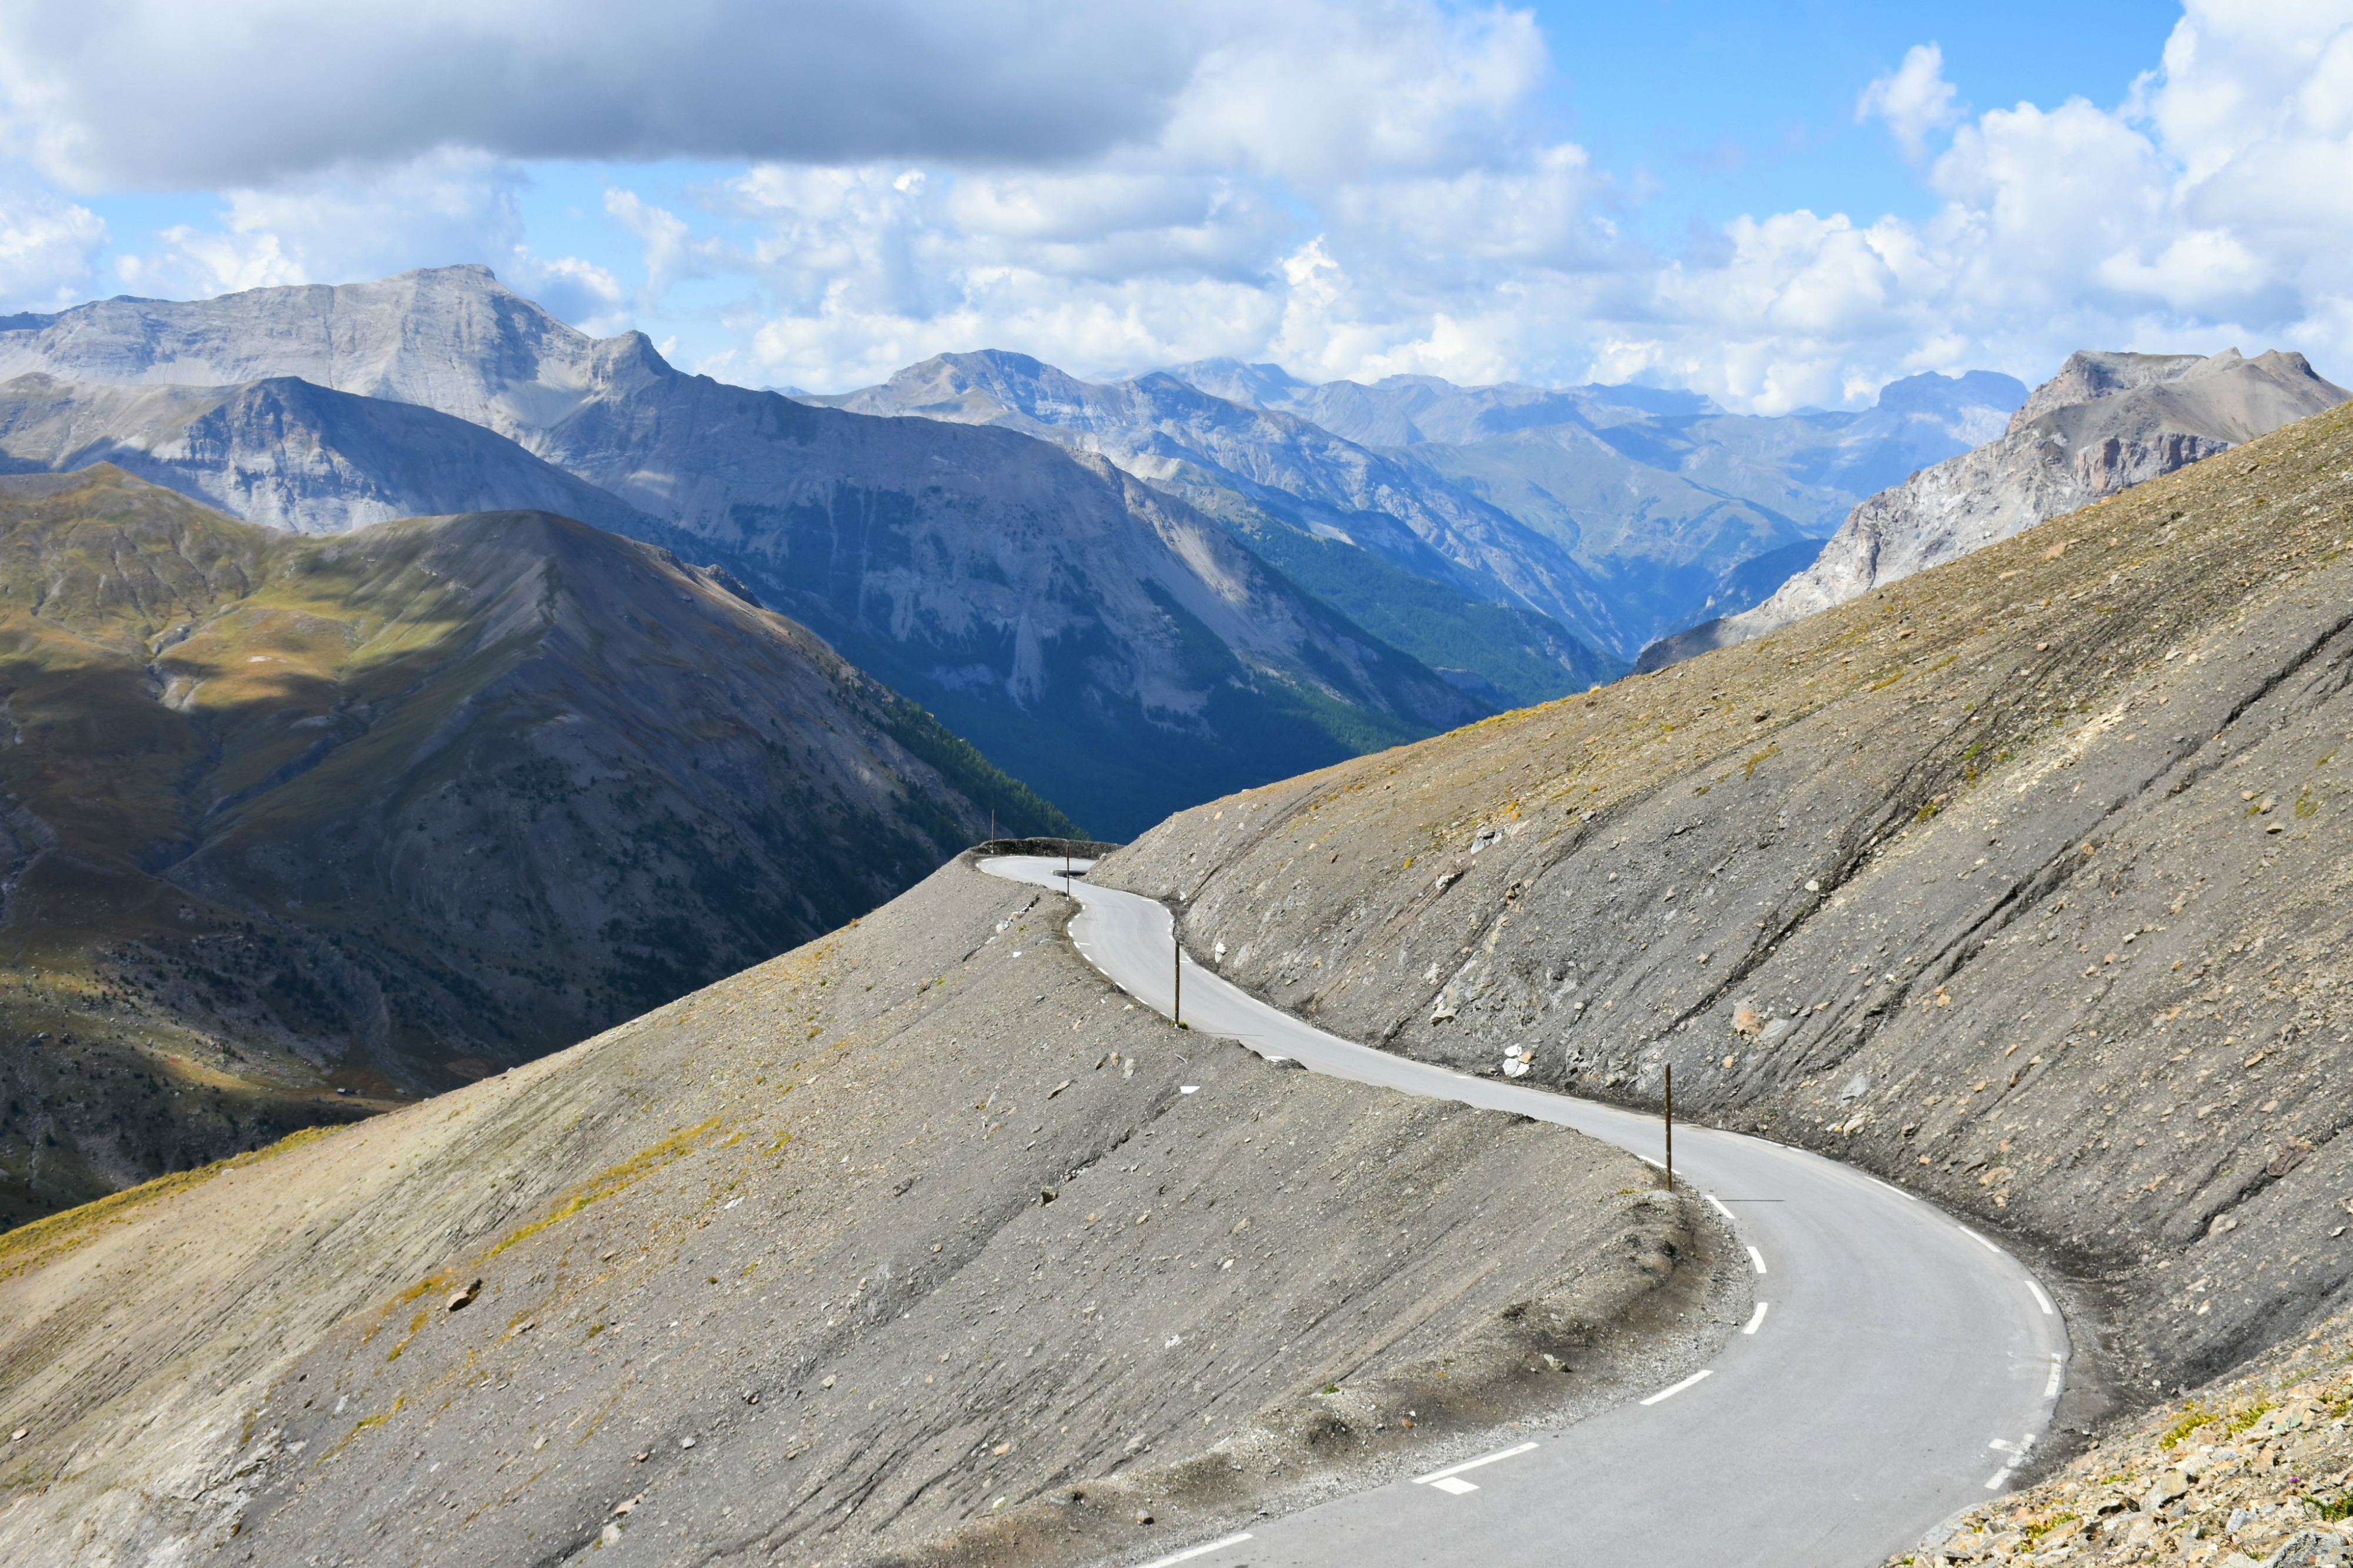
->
[[0, 469, 1068, 1220]]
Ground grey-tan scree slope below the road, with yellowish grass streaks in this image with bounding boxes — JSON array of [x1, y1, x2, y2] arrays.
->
[[0, 862, 1739, 1568]]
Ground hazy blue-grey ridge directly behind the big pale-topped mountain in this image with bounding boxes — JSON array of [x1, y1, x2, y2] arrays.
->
[[802, 351, 1626, 668]]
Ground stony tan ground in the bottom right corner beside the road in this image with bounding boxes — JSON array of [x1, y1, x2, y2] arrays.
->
[[1889, 1316, 2353, 1568]]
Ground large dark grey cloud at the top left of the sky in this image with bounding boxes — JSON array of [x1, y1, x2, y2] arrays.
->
[[0, 0, 1221, 188]]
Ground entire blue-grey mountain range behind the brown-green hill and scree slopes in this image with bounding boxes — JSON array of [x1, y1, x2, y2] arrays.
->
[[0, 266, 2024, 836]]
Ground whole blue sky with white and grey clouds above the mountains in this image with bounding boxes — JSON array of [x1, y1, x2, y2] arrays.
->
[[0, 0, 2353, 412]]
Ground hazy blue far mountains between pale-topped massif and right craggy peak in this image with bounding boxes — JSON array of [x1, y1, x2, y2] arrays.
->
[[800, 351, 2026, 663]]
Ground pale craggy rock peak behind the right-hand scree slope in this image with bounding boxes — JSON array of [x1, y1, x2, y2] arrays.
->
[[1642, 348, 2353, 669]]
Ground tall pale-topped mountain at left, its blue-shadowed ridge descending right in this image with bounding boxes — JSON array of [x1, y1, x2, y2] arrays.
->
[[0, 266, 1487, 836]]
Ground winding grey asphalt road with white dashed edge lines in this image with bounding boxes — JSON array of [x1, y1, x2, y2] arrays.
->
[[981, 855, 2068, 1568]]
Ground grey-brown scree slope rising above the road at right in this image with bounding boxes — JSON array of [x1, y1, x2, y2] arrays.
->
[[1096, 410, 2353, 1394]]
